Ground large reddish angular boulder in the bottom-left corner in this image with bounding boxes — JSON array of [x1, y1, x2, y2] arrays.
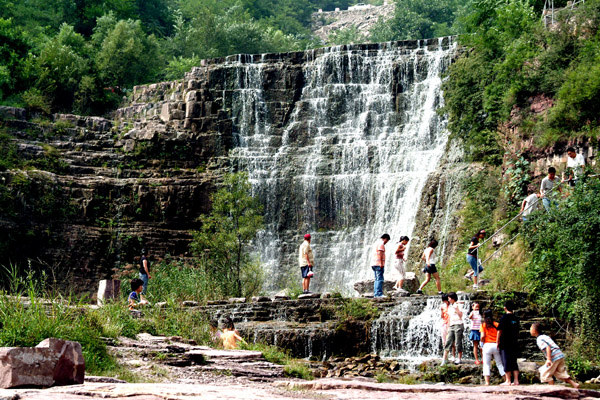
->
[[0, 338, 85, 388]]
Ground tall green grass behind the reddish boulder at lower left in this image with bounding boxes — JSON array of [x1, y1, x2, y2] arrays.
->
[[0, 265, 210, 381]]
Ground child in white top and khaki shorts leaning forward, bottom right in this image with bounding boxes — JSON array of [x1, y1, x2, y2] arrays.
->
[[529, 323, 579, 389]]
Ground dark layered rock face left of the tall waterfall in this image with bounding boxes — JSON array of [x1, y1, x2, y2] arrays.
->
[[0, 110, 220, 292]]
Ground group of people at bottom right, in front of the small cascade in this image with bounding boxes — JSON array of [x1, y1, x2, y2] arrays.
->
[[440, 292, 579, 388]]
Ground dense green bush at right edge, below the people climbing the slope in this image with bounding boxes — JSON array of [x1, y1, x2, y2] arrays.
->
[[523, 179, 600, 359]]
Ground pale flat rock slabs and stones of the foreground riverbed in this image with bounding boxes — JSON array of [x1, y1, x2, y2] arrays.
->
[[0, 334, 600, 400]]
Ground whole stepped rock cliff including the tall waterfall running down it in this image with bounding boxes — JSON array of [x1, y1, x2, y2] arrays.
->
[[2, 38, 455, 293]]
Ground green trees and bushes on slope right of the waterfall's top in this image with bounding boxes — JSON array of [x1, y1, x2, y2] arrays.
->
[[444, 0, 600, 156]]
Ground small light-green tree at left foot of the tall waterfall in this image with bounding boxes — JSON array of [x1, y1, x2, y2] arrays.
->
[[190, 173, 263, 296]]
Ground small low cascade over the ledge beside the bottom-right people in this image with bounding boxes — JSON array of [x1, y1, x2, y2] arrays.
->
[[371, 294, 473, 365]]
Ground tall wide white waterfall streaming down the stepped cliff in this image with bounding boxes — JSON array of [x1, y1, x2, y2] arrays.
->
[[223, 38, 455, 293]]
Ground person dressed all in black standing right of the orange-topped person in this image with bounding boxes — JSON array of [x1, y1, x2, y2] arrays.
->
[[496, 300, 519, 385]]
